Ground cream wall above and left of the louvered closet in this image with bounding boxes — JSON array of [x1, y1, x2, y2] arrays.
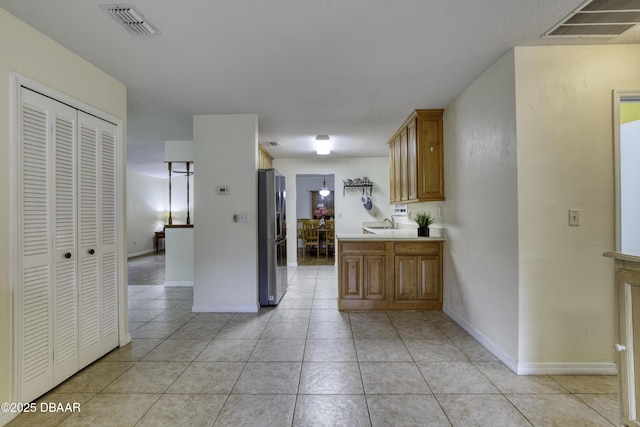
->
[[0, 9, 126, 408]]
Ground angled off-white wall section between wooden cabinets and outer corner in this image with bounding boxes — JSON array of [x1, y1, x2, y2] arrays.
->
[[443, 52, 518, 370]]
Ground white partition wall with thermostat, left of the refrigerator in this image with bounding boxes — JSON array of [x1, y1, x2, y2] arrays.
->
[[193, 114, 258, 312]]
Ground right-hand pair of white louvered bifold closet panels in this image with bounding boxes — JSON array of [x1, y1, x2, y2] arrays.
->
[[78, 112, 118, 368]]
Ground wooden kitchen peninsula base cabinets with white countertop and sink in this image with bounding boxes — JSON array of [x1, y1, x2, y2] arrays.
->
[[336, 228, 444, 310]]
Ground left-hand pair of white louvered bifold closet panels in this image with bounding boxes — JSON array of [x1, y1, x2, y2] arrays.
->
[[20, 89, 78, 402]]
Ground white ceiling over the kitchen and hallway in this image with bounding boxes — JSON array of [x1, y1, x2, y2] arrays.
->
[[0, 0, 640, 177]]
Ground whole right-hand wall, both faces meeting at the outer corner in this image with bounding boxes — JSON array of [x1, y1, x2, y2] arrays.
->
[[444, 41, 640, 374]]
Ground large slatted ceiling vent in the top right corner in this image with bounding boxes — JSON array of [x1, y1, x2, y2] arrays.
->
[[543, 0, 640, 38]]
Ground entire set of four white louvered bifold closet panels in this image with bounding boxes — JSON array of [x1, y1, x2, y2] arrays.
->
[[15, 88, 119, 402]]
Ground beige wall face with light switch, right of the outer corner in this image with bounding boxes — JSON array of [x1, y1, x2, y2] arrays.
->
[[515, 45, 640, 372]]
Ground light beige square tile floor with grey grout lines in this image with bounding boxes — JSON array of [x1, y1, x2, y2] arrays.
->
[[10, 260, 618, 427]]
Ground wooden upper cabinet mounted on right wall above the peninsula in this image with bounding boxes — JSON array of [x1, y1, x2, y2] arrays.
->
[[389, 110, 444, 203]]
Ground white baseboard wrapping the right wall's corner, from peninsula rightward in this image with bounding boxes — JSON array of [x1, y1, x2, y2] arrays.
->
[[442, 307, 617, 375]]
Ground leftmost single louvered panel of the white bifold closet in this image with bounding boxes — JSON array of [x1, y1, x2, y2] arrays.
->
[[18, 90, 53, 398]]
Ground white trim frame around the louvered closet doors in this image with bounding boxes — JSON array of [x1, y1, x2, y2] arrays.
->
[[9, 71, 131, 402]]
